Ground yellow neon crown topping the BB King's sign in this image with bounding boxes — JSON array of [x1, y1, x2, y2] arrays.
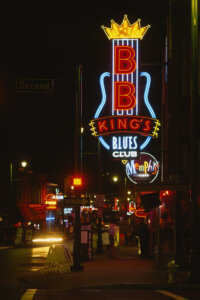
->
[[101, 15, 151, 40]]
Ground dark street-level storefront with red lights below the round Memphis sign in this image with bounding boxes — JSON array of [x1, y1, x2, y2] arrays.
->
[[134, 184, 191, 267]]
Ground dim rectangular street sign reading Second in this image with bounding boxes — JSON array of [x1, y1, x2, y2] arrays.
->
[[16, 78, 54, 94]]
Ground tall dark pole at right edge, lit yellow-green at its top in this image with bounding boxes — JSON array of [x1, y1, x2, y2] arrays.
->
[[189, 0, 200, 283]]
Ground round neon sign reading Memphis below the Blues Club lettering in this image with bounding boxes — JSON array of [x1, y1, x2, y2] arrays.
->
[[126, 152, 159, 184]]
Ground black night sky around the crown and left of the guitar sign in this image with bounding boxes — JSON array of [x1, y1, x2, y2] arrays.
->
[[0, 0, 167, 191]]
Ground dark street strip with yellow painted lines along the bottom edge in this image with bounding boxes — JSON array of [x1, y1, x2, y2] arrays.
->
[[3, 288, 200, 300]]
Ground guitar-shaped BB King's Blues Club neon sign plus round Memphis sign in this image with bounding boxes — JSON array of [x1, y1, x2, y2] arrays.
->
[[90, 15, 160, 184]]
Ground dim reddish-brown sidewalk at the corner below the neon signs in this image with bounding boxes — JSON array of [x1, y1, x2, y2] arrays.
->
[[21, 245, 200, 289]]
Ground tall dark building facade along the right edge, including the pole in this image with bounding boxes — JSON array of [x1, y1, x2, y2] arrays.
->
[[157, 0, 200, 276]]
